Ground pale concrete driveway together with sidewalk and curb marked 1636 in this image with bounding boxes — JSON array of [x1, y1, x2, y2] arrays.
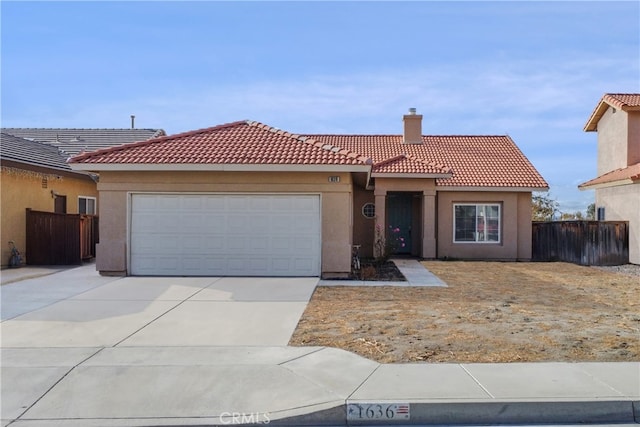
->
[[0, 266, 640, 427]]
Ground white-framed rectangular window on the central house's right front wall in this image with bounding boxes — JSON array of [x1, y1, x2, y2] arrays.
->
[[453, 203, 501, 243]]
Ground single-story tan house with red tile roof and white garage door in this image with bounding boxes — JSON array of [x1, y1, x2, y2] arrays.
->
[[70, 110, 548, 277]]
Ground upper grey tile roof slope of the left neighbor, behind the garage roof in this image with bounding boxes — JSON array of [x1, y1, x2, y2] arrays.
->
[[2, 128, 165, 156]]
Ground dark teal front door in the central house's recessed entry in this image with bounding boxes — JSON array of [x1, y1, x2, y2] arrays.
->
[[387, 193, 413, 254]]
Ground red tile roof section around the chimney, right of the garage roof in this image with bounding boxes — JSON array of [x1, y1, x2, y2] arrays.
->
[[310, 135, 548, 188]]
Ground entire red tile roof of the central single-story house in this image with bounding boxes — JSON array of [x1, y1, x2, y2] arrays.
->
[[70, 121, 548, 188]]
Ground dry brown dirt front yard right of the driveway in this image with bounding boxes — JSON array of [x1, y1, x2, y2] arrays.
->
[[290, 261, 640, 363]]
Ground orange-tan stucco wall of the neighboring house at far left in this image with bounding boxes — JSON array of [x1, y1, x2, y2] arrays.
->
[[0, 162, 98, 267]]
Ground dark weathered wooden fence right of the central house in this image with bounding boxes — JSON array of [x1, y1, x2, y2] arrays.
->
[[532, 221, 629, 265]]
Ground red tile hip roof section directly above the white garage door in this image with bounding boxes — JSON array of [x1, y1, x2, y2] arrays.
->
[[70, 121, 371, 165]]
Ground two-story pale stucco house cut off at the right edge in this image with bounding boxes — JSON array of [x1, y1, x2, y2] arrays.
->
[[578, 93, 640, 264]]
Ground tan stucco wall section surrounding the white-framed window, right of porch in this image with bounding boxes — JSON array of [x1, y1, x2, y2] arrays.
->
[[437, 192, 531, 260]]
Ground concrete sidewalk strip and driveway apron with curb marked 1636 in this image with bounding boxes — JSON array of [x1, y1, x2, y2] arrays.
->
[[2, 346, 640, 426]]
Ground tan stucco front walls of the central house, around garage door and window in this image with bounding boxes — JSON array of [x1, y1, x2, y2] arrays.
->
[[96, 167, 531, 277]]
